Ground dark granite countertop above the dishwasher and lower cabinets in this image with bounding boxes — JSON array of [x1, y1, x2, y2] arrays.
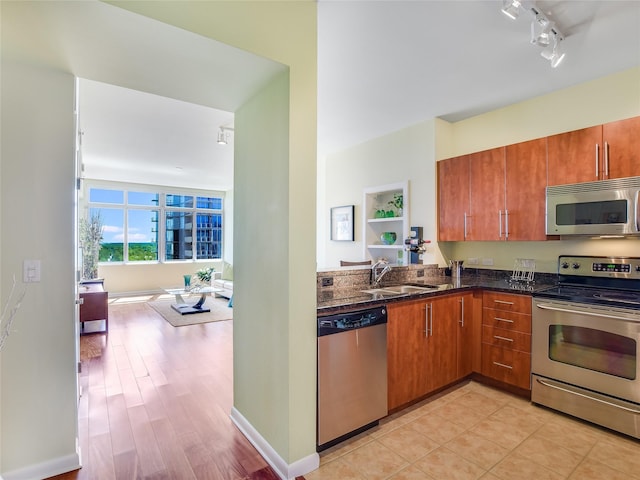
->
[[318, 275, 555, 316]]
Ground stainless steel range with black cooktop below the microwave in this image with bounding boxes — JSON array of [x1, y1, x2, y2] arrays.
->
[[531, 256, 640, 438]]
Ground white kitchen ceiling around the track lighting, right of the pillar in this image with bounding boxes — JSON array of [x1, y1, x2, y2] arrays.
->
[[318, 0, 640, 152]]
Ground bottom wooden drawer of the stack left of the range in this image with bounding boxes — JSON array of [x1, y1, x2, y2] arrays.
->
[[482, 343, 531, 390]]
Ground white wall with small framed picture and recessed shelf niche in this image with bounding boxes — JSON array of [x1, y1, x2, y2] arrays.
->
[[318, 120, 441, 268]]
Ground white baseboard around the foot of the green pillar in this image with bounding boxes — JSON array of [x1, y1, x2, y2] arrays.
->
[[231, 408, 320, 480]]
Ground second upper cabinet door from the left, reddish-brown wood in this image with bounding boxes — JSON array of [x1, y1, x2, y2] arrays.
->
[[467, 147, 505, 241]]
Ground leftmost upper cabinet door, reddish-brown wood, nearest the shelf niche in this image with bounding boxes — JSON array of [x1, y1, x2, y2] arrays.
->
[[437, 155, 469, 242]]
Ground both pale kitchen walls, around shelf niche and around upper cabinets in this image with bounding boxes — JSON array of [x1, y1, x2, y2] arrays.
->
[[318, 67, 640, 272]]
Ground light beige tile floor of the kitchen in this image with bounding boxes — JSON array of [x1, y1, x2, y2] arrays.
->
[[305, 382, 640, 480]]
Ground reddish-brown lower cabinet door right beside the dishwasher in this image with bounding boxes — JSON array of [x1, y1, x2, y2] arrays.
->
[[387, 302, 428, 410]]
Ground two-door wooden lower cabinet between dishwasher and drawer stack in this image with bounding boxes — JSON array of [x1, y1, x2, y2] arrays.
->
[[387, 292, 479, 410]]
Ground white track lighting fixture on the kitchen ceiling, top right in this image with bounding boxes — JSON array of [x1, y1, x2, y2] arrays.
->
[[502, 0, 565, 68]]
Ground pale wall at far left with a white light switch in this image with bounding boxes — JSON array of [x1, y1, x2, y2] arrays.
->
[[0, 62, 79, 479]]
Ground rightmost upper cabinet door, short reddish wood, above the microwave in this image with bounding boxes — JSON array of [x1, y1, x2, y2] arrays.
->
[[602, 117, 640, 178]]
